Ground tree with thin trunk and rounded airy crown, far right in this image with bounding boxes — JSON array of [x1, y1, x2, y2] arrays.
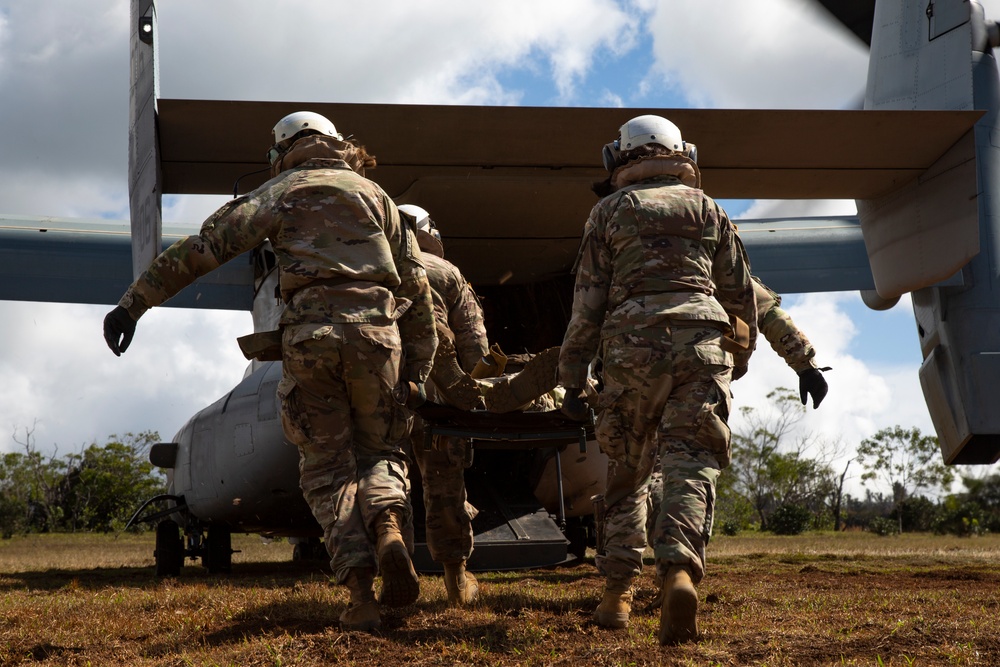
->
[[857, 426, 954, 532]]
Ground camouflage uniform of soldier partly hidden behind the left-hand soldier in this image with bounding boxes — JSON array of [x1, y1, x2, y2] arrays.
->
[[413, 253, 489, 563]]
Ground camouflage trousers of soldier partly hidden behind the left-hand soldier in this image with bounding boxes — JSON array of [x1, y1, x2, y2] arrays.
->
[[412, 417, 478, 563]]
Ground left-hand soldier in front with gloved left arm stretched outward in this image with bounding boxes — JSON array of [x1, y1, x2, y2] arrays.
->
[[104, 111, 437, 630]]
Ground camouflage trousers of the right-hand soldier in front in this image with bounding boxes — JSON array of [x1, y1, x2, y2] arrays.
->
[[595, 326, 732, 582]]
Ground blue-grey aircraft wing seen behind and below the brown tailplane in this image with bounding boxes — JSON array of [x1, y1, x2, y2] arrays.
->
[[0, 216, 874, 310]]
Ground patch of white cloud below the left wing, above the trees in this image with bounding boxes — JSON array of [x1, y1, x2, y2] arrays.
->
[[0, 302, 252, 453]]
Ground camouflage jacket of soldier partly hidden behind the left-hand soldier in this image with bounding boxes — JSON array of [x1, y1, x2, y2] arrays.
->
[[423, 253, 490, 373]]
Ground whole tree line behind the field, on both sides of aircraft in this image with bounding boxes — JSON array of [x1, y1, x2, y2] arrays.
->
[[0, 396, 1000, 538]]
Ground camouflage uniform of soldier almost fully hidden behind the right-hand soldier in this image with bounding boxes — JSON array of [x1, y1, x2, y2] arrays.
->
[[646, 276, 817, 544]]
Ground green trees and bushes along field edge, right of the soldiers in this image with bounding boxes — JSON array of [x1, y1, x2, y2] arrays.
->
[[716, 388, 1000, 535]]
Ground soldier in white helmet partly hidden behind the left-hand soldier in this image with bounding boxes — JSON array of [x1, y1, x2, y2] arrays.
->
[[399, 204, 489, 606]]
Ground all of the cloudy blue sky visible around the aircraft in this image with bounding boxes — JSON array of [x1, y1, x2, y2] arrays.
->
[[0, 0, 1000, 498]]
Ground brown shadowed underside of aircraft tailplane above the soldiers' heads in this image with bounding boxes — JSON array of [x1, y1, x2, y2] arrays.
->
[[157, 99, 981, 285]]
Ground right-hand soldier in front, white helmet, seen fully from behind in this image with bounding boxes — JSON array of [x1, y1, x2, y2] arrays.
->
[[559, 115, 757, 644]]
